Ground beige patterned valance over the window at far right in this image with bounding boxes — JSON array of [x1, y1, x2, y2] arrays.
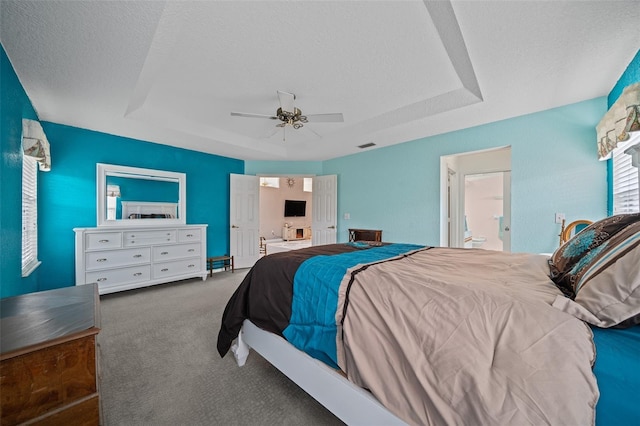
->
[[596, 83, 640, 160]]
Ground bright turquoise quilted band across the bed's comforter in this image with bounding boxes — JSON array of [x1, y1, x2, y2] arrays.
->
[[283, 244, 424, 368]]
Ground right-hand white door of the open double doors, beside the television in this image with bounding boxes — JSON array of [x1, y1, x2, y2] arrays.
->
[[311, 175, 338, 246]]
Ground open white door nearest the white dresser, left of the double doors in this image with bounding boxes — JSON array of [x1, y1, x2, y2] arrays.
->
[[229, 174, 260, 268]]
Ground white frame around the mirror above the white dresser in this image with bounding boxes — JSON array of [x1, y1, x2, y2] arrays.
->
[[96, 163, 187, 226]]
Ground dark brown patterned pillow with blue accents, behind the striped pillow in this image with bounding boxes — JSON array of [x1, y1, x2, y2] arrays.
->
[[549, 213, 640, 299]]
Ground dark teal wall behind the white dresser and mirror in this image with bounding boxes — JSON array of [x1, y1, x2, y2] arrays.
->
[[38, 122, 244, 290]]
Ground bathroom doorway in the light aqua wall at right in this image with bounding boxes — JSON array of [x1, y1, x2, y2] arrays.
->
[[440, 147, 511, 251]]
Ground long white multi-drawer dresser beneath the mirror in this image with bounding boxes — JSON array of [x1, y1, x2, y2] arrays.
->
[[74, 225, 208, 294]]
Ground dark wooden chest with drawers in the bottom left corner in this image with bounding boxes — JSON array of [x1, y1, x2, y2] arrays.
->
[[0, 284, 100, 426]]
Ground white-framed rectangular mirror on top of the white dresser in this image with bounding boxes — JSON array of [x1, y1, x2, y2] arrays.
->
[[96, 163, 187, 226]]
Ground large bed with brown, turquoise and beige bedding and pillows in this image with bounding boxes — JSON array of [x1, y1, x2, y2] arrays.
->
[[218, 215, 640, 424]]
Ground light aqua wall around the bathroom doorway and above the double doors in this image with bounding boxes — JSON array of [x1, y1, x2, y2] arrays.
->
[[245, 97, 607, 253]]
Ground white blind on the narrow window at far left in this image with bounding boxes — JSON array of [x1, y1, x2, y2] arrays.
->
[[22, 155, 40, 277]]
